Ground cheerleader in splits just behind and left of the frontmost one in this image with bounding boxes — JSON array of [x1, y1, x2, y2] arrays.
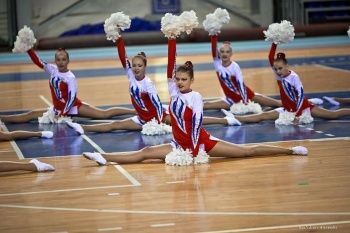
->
[[67, 36, 237, 135]]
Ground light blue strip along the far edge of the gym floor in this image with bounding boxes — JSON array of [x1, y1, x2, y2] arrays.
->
[[0, 32, 350, 64]]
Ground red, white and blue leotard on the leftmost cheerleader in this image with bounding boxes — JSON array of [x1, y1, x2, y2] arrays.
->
[[27, 49, 82, 116]]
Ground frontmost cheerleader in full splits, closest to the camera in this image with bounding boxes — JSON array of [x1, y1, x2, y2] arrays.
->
[[83, 38, 307, 165]]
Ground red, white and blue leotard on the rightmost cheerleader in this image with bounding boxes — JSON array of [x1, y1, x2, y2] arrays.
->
[[269, 43, 314, 117]]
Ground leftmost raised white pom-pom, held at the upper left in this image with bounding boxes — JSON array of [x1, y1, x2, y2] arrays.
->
[[12, 25, 36, 53]]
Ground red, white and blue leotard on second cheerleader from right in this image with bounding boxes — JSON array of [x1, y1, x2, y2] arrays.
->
[[211, 35, 255, 105]]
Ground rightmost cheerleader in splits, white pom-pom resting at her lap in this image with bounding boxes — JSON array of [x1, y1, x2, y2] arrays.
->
[[222, 43, 350, 125]]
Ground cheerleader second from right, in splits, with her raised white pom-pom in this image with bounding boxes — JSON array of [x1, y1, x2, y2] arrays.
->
[[203, 8, 323, 114]]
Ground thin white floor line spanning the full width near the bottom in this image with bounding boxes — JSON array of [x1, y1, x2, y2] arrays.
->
[[0, 204, 350, 217]]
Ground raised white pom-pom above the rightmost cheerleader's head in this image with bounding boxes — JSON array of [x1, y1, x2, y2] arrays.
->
[[263, 20, 295, 44]]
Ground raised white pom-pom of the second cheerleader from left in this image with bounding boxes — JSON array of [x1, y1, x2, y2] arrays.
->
[[104, 12, 131, 42]]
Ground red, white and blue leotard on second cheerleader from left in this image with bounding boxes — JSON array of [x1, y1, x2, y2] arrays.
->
[[116, 37, 166, 125]]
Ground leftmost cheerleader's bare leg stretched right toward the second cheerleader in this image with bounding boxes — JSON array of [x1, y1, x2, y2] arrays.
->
[[78, 104, 136, 119]]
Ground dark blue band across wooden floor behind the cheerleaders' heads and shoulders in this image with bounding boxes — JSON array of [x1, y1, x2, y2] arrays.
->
[[0, 55, 350, 82]]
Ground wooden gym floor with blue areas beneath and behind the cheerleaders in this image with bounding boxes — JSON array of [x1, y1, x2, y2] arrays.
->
[[0, 36, 350, 233]]
